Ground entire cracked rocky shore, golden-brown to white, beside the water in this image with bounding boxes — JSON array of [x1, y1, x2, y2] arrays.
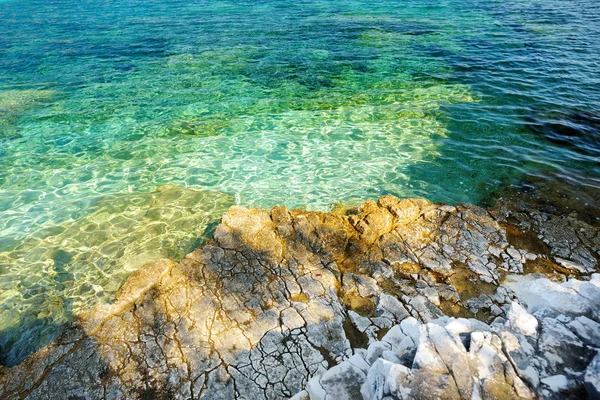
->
[[0, 196, 600, 400]]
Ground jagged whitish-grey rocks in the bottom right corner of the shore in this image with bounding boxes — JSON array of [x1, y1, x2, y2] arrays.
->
[[304, 274, 600, 400]]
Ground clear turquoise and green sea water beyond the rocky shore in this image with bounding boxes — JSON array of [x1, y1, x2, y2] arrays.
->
[[0, 0, 600, 365]]
